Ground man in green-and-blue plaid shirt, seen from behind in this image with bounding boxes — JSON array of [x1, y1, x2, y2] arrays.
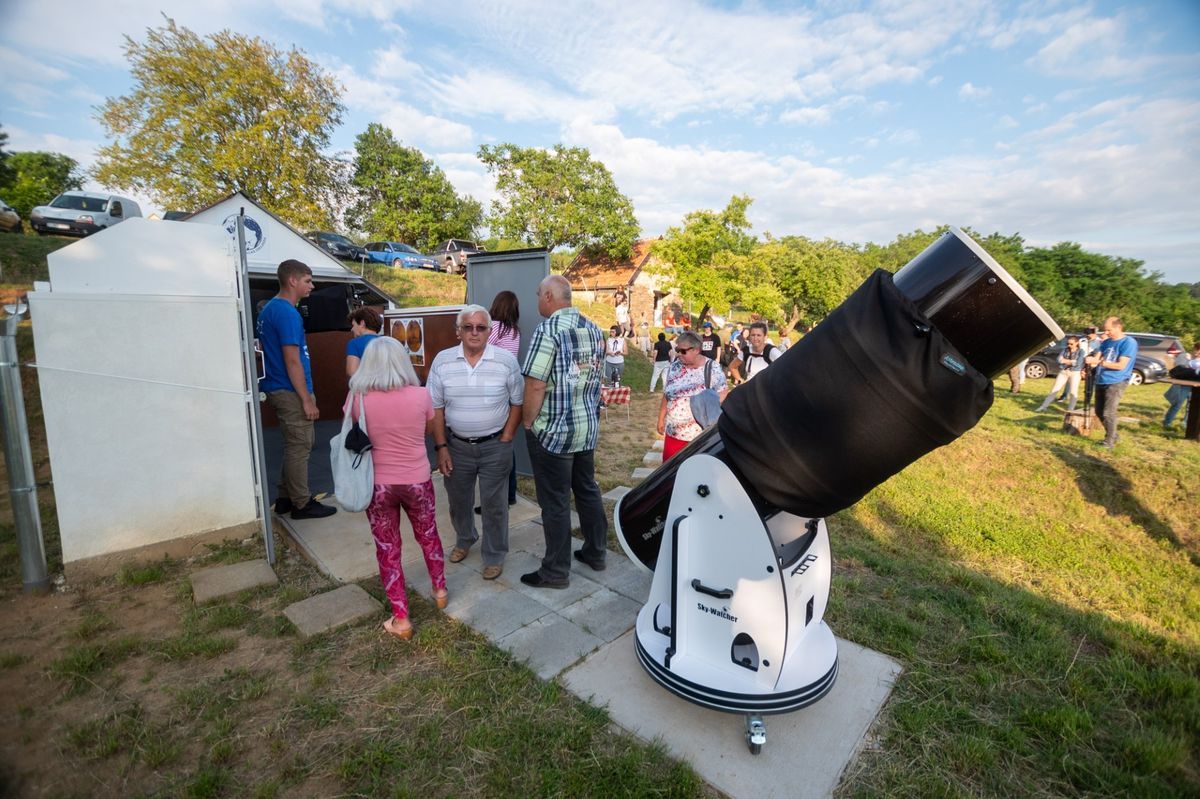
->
[[521, 275, 608, 588]]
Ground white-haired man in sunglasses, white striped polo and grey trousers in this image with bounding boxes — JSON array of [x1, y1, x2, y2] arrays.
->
[[426, 305, 524, 579]]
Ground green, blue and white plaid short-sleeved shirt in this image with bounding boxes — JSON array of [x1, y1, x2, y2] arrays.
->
[[521, 307, 604, 455]]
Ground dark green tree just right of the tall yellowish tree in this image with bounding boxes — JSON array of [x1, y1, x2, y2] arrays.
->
[[346, 122, 482, 252]]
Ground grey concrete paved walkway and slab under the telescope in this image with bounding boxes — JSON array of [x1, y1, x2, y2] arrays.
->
[[276, 475, 900, 799]]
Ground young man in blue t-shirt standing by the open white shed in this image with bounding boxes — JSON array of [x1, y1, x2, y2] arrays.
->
[[258, 259, 337, 518]]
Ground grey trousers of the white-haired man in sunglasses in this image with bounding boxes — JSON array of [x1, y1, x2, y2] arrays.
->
[[443, 435, 512, 566]]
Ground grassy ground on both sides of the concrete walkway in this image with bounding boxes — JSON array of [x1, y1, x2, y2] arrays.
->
[[0, 279, 1200, 797]]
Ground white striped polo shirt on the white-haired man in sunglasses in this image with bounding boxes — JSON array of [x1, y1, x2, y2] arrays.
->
[[425, 344, 524, 438]]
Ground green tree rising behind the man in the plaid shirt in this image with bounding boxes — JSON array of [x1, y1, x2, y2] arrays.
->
[[479, 143, 640, 258]]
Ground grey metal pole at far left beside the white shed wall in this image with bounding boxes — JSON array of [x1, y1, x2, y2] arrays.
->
[[0, 305, 50, 594]]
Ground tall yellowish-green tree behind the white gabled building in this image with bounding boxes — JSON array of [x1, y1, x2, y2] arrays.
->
[[95, 19, 343, 228]]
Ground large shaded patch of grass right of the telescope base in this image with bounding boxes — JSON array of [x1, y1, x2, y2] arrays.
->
[[826, 498, 1200, 797]]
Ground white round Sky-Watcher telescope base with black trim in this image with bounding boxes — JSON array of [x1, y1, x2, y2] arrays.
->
[[623, 455, 838, 753]]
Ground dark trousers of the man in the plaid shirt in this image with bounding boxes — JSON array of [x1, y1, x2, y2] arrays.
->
[[526, 432, 608, 579]]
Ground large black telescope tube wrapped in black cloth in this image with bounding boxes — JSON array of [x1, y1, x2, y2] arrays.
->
[[613, 228, 1062, 569]]
